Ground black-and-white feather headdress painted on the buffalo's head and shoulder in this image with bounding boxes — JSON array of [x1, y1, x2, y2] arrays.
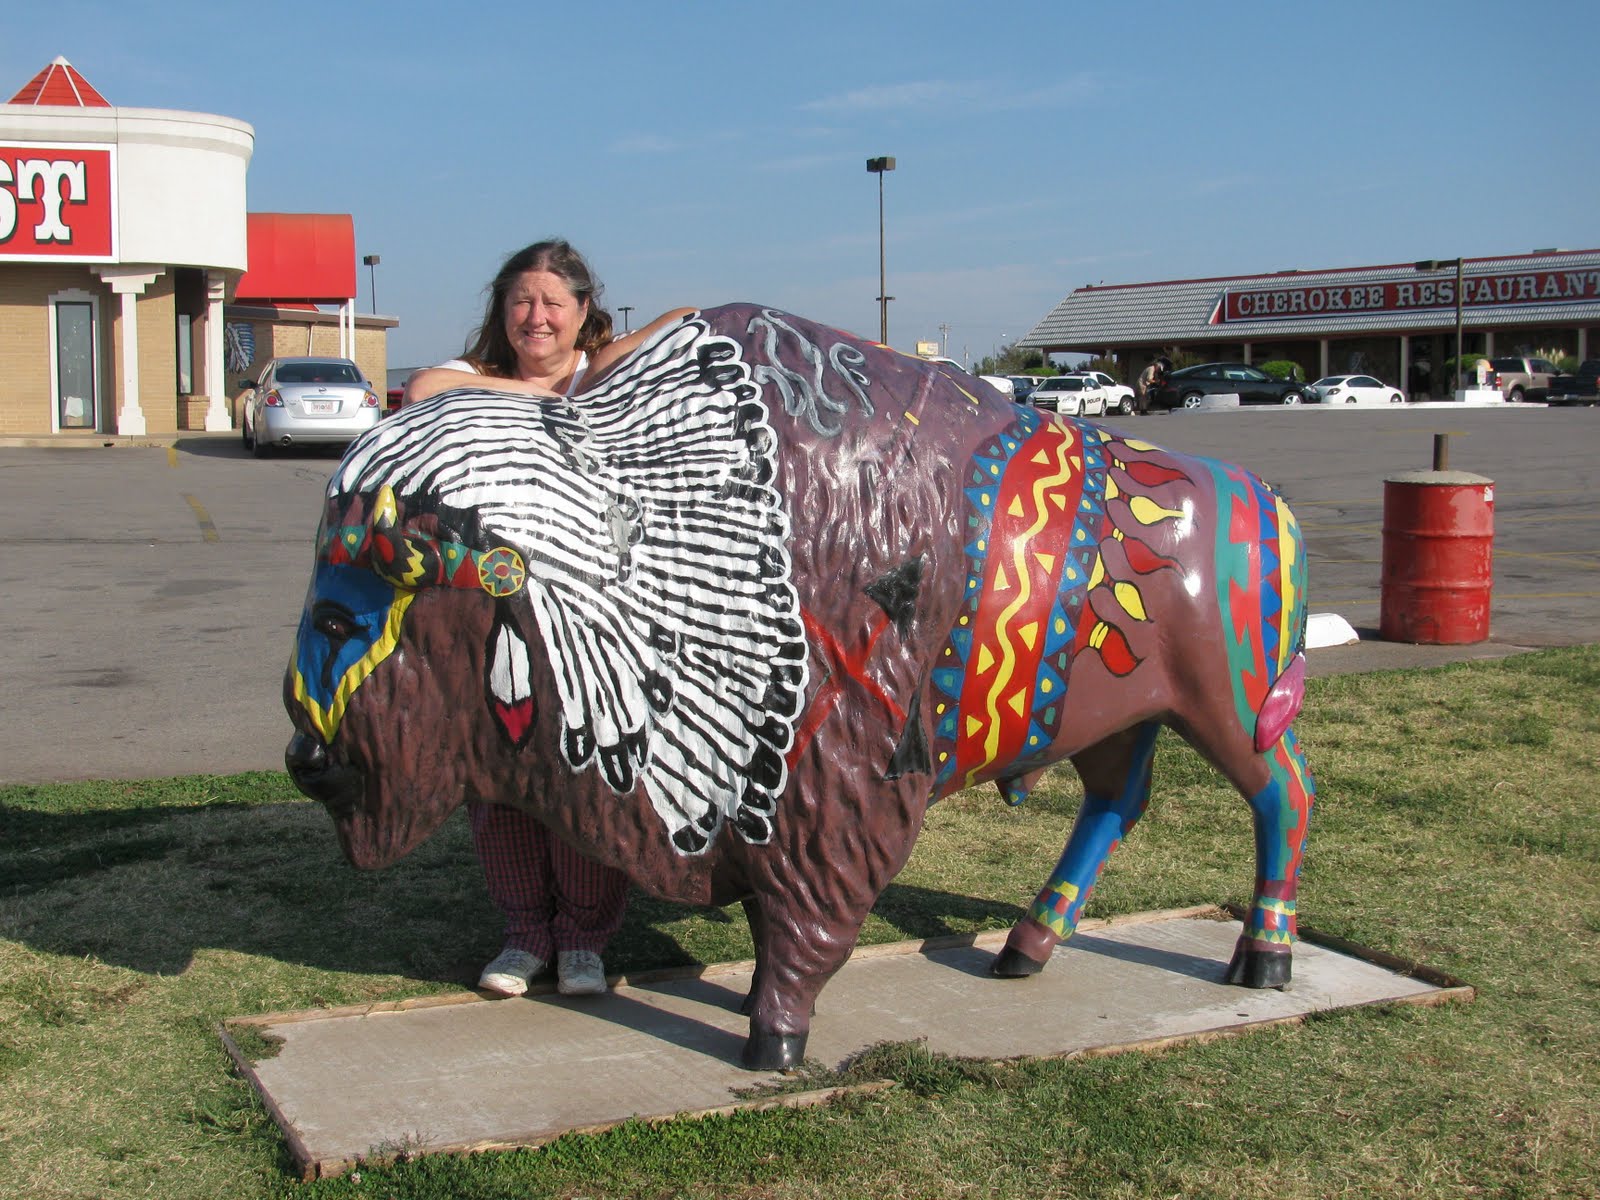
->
[[330, 318, 806, 853]]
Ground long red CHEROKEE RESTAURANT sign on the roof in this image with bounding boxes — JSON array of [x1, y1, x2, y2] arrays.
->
[[1211, 267, 1600, 325]]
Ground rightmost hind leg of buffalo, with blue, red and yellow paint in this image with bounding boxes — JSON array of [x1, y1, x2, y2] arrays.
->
[[1227, 730, 1315, 987]]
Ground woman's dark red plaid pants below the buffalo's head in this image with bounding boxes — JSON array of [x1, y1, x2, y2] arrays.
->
[[467, 805, 627, 962]]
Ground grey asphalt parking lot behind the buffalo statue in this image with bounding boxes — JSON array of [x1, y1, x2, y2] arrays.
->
[[0, 406, 1600, 782]]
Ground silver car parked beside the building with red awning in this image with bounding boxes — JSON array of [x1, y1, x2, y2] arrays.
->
[[238, 357, 384, 458]]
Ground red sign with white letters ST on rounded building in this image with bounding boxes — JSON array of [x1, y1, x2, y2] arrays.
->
[[0, 144, 117, 261]]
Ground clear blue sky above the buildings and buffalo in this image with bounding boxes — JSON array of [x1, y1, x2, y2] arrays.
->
[[0, 0, 1600, 366]]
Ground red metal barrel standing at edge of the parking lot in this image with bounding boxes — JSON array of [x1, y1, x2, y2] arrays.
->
[[1378, 470, 1494, 646]]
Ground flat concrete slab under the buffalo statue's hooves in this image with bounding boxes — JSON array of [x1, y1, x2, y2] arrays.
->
[[224, 909, 1470, 1178]]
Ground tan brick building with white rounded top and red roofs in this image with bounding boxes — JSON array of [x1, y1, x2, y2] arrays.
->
[[0, 58, 397, 438]]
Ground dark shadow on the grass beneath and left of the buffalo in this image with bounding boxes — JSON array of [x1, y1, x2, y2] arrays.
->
[[0, 803, 1019, 987]]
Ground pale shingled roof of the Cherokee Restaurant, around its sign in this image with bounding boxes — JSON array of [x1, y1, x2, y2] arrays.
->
[[1018, 250, 1600, 350]]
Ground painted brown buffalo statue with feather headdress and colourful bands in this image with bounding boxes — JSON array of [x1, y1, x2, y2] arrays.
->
[[285, 304, 1314, 1069]]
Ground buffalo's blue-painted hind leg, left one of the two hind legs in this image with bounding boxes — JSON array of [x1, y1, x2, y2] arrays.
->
[[990, 722, 1160, 979]]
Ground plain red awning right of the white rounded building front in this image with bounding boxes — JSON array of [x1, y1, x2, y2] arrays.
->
[[234, 213, 355, 304]]
